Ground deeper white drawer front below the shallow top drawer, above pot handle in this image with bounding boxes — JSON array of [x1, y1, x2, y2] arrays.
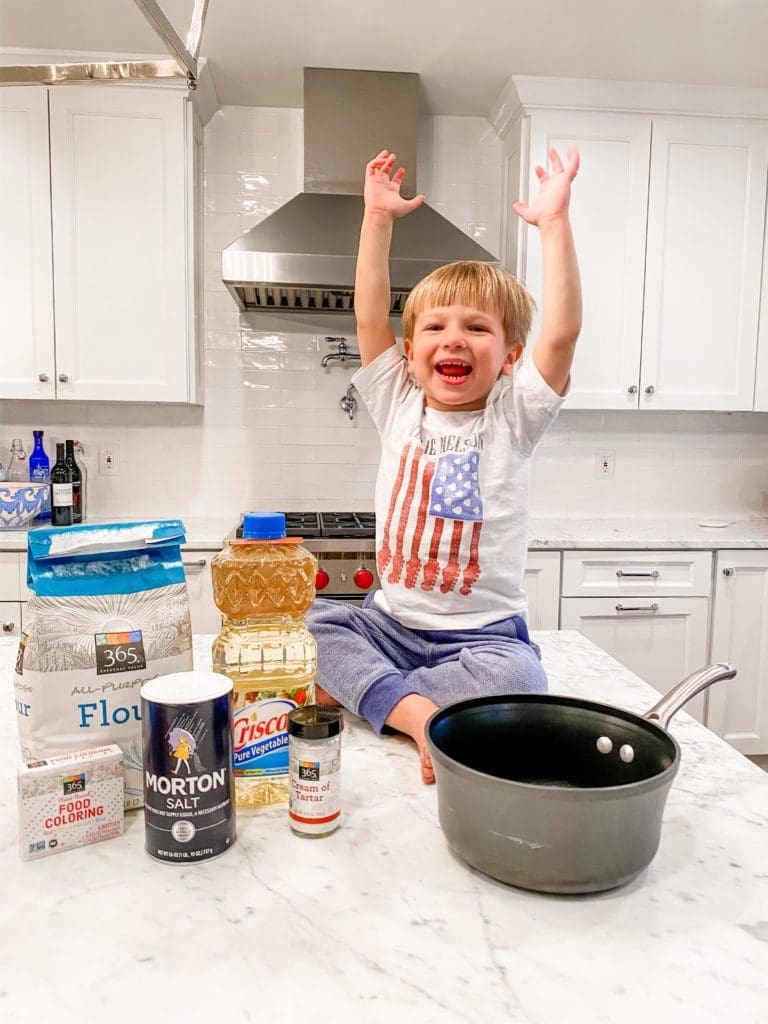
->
[[560, 597, 710, 722]]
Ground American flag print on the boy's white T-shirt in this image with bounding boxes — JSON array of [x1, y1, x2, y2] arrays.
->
[[376, 441, 482, 597]]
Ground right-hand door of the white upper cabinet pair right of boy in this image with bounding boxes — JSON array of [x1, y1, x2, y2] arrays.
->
[[640, 118, 768, 411]]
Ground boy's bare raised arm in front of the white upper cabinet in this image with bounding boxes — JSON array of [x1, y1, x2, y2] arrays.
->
[[512, 147, 582, 394]]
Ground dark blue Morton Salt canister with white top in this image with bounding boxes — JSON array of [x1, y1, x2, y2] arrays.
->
[[141, 672, 236, 864]]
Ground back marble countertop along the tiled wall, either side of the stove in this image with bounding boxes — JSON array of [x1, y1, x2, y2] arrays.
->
[[0, 513, 768, 551]]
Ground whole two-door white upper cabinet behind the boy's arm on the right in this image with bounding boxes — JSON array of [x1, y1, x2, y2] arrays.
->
[[504, 98, 768, 411]]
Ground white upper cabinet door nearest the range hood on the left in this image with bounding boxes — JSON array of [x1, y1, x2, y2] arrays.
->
[[50, 85, 191, 401]]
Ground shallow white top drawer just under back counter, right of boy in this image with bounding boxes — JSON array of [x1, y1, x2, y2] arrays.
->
[[562, 551, 712, 597]]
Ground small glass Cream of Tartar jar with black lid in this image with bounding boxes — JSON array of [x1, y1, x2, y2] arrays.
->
[[288, 705, 344, 839]]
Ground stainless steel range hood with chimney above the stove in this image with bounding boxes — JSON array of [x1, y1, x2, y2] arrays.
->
[[221, 68, 499, 315]]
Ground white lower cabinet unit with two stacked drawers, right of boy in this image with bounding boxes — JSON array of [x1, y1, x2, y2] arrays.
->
[[560, 551, 712, 722]]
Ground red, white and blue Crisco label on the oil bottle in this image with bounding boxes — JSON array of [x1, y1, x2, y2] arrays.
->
[[232, 686, 307, 778]]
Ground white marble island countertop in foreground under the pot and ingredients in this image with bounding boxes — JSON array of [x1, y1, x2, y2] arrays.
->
[[0, 632, 768, 1024]]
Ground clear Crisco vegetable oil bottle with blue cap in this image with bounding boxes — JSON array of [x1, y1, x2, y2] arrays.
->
[[211, 512, 317, 808]]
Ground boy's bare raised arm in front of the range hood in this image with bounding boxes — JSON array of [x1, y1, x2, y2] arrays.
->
[[354, 150, 424, 367]]
